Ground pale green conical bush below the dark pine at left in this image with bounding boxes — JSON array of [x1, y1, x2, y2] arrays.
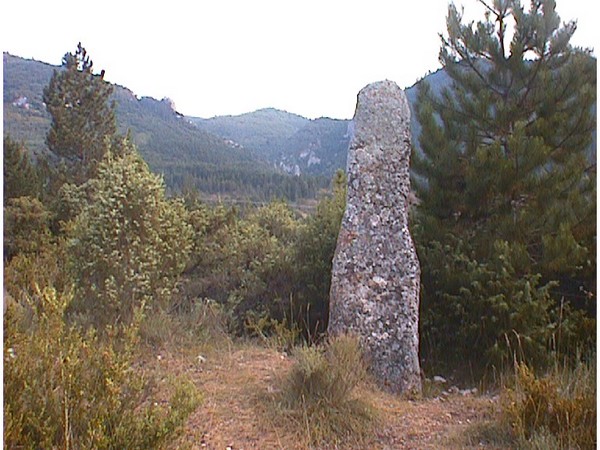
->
[[68, 142, 192, 327]]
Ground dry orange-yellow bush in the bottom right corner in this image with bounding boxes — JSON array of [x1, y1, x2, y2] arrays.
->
[[503, 362, 596, 449]]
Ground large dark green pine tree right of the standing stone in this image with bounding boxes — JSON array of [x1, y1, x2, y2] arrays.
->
[[413, 0, 596, 370]]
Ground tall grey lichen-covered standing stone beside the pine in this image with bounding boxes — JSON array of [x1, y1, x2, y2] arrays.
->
[[328, 81, 421, 393]]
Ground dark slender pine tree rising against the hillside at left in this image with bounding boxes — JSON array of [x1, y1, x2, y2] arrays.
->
[[43, 43, 116, 184]]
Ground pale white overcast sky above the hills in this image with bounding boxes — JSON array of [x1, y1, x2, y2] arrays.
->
[[0, 0, 600, 119]]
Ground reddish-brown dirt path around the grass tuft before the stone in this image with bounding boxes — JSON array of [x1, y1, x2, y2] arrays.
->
[[146, 345, 506, 450]]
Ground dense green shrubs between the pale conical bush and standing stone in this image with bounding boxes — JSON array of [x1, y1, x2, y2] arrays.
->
[[183, 173, 345, 337]]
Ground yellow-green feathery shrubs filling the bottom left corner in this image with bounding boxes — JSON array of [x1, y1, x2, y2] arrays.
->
[[4, 288, 198, 449]]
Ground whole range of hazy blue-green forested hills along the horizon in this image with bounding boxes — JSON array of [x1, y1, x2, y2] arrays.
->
[[3, 53, 596, 200]]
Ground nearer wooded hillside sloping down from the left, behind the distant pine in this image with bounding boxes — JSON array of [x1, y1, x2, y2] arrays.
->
[[3, 53, 325, 200]]
